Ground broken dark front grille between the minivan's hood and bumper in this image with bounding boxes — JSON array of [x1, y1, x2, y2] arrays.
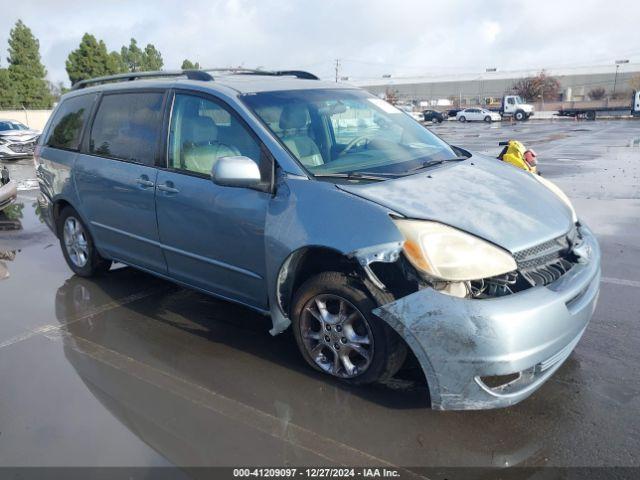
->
[[513, 227, 578, 286]]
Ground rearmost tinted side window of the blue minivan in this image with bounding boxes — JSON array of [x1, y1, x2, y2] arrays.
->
[[45, 95, 96, 150]]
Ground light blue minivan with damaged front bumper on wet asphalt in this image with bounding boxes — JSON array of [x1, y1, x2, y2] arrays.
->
[[36, 70, 600, 409]]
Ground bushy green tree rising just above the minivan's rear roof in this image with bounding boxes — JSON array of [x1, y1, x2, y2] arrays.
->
[[65, 33, 123, 85]]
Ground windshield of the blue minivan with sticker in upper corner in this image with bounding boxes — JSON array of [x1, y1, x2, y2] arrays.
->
[[243, 89, 456, 176]]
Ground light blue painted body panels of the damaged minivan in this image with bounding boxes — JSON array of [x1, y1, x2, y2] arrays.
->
[[37, 79, 599, 409]]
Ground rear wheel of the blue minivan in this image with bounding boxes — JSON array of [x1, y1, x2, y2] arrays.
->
[[56, 207, 111, 277]]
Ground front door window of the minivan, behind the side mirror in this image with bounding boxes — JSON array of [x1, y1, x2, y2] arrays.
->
[[169, 94, 264, 175]]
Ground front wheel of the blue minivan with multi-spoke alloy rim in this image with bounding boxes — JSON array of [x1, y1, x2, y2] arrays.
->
[[291, 272, 407, 384]]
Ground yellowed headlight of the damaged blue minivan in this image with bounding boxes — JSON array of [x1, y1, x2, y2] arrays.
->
[[394, 219, 518, 282]]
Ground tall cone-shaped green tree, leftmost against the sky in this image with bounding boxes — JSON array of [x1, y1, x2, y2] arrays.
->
[[7, 20, 52, 108]]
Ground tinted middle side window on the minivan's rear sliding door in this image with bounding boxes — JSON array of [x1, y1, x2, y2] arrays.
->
[[89, 92, 164, 165]]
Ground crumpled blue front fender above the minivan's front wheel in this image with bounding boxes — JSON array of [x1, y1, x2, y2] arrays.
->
[[265, 176, 403, 335]]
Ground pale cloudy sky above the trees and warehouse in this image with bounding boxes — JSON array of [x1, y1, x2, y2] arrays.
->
[[0, 0, 640, 84]]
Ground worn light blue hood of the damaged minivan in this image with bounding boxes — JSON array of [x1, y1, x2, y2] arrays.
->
[[338, 155, 572, 252]]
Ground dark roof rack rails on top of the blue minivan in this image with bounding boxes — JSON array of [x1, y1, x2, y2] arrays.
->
[[71, 68, 319, 90]]
